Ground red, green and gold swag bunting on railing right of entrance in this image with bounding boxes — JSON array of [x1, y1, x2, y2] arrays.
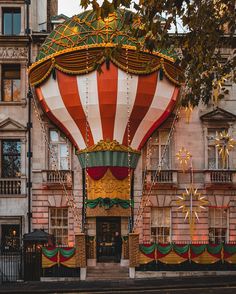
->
[[139, 243, 236, 264]]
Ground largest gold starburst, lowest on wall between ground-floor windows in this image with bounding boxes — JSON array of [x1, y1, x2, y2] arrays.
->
[[176, 186, 208, 224]]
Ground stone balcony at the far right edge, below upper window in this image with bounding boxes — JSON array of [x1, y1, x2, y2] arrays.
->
[[205, 170, 236, 187]]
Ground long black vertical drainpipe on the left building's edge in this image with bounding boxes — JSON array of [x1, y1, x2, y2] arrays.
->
[[25, 0, 33, 233]]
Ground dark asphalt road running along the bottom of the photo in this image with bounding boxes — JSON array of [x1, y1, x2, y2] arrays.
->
[[0, 276, 236, 294]]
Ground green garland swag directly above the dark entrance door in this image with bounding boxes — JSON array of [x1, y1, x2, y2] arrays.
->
[[86, 197, 133, 209]]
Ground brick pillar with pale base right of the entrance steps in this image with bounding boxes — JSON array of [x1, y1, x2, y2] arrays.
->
[[129, 233, 139, 279]]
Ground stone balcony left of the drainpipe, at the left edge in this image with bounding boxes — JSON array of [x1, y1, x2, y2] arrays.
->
[[0, 178, 26, 196]]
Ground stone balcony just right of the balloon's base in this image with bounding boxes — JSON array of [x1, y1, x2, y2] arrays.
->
[[146, 170, 177, 187]]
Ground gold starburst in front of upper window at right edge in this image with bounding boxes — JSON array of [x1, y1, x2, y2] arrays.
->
[[215, 131, 236, 169]]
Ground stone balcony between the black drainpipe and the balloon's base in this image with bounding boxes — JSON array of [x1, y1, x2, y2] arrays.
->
[[42, 170, 73, 188]]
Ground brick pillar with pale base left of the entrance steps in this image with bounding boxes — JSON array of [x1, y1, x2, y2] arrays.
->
[[75, 233, 86, 280]]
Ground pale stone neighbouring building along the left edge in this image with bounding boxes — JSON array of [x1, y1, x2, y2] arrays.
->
[[0, 0, 57, 250]]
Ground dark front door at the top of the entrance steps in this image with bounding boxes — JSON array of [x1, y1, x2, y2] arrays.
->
[[96, 217, 121, 262]]
